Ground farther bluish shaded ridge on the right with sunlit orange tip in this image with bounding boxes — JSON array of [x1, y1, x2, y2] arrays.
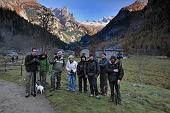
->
[[96, 1, 146, 40]]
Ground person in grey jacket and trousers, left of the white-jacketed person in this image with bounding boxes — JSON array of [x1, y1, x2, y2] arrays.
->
[[50, 51, 65, 90]]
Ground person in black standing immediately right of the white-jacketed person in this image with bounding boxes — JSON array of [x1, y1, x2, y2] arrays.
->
[[77, 56, 87, 93]]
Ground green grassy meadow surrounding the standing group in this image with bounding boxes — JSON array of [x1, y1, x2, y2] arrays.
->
[[0, 56, 170, 113]]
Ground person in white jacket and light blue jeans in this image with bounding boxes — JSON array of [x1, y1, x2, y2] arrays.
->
[[66, 55, 78, 92]]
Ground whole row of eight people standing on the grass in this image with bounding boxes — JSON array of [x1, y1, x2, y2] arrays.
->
[[25, 48, 124, 103]]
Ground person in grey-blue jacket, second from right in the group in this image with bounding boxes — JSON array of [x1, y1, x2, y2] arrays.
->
[[99, 53, 109, 95]]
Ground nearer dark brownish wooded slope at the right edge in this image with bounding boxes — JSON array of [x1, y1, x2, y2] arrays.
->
[[124, 0, 170, 56]]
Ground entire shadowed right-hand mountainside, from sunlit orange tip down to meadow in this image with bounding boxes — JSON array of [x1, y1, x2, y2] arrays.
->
[[93, 0, 170, 56]]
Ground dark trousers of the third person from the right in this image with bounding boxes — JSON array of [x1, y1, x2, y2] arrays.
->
[[88, 76, 99, 96]]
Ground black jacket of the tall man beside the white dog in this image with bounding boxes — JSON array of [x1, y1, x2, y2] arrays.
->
[[25, 55, 39, 72]]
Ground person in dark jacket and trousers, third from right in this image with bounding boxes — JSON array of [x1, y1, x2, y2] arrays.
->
[[86, 54, 100, 99]]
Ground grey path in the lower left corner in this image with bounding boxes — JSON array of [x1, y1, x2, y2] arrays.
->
[[0, 80, 54, 113]]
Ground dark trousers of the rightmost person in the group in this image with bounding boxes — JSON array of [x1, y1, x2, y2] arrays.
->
[[109, 81, 121, 102]]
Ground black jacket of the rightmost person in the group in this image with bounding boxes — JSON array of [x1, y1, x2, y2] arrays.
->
[[106, 62, 124, 81]]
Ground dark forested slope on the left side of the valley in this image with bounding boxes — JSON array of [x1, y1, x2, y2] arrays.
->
[[0, 8, 66, 50]]
